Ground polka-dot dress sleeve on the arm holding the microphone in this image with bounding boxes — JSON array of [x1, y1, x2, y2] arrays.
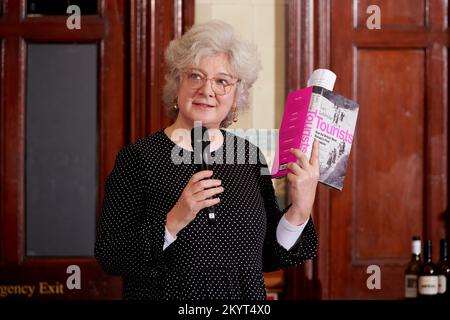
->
[[95, 145, 165, 277]]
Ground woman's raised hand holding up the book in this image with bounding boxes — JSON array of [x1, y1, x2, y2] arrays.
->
[[285, 140, 320, 225]]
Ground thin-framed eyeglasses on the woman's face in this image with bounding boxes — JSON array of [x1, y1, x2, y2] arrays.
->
[[185, 70, 241, 96]]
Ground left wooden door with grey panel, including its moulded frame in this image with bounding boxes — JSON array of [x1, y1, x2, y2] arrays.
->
[[0, 0, 194, 299]]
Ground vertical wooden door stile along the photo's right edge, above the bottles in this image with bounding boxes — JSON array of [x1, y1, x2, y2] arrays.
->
[[424, 42, 450, 250]]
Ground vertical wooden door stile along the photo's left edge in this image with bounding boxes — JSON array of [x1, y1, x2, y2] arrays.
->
[[2, 37, 25, 264]]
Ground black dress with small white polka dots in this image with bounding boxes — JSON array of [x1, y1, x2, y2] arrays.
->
[[95, 130, 317, 300]]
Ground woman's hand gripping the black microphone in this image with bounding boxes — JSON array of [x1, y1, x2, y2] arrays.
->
[[166, 170, 223, 236]]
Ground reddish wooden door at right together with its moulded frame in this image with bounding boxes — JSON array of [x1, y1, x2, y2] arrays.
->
[[288, 0, 449, 299]]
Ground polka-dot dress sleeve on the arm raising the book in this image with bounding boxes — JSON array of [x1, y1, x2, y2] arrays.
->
[[258, 151, 318, 272]]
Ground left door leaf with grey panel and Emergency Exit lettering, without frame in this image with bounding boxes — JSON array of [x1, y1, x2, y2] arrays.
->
[[0, 0, 127, 299]]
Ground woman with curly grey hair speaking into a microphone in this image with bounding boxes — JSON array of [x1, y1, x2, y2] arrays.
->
[[95, 21, 319, 300]]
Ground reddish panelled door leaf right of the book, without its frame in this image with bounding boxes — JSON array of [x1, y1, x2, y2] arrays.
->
[[330, 1, 448, 299]]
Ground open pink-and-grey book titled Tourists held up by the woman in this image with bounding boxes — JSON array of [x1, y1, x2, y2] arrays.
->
[[272, 70, 359, 190]]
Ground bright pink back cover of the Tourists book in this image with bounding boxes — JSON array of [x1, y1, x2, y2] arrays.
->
[[272, 87, 313, 178]]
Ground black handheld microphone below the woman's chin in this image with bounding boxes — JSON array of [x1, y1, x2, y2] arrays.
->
[[191, 126, 216, 224]]
